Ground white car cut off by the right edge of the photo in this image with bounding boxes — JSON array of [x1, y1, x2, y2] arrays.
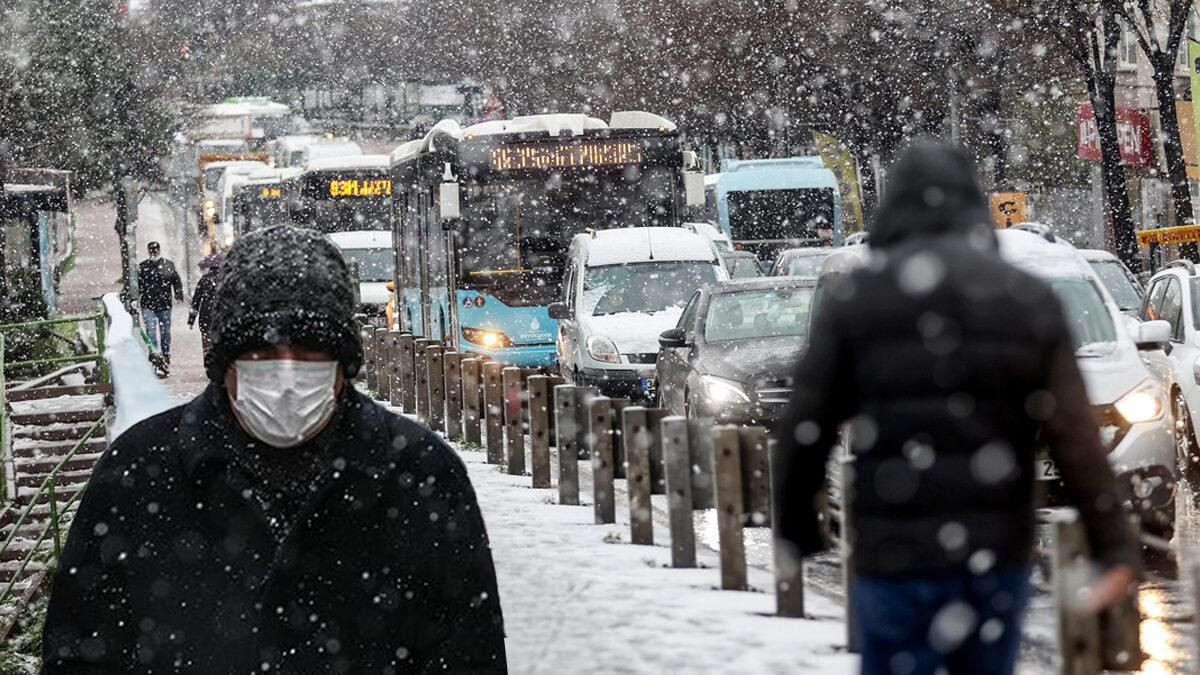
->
[[1139, 261, 1200, 492]]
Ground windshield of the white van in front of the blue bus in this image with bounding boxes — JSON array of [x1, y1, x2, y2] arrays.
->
[[580, 262, 716, 316]]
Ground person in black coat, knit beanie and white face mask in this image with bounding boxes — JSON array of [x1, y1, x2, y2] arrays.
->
[[43, 226, 506, 675]]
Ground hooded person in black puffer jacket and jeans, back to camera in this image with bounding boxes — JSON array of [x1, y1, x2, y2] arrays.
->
[[776, 142, 1140, 675]]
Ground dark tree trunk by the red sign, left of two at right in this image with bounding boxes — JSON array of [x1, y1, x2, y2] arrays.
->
[[1088, 67, 1141, 274]]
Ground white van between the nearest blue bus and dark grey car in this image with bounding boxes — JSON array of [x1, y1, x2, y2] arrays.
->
[[550, 227, 728, 400]]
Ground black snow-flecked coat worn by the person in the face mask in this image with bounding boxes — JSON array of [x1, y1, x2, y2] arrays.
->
[[43, 386, 506, 675]]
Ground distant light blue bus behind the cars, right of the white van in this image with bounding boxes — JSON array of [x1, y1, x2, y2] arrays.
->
[[708, 157, 842, 263]]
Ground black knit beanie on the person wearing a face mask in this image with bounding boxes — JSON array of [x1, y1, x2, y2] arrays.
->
[[204, 225, 362, 382]]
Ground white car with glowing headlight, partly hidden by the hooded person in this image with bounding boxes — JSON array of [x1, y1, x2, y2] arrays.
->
[[997, 223, 1176, 533]]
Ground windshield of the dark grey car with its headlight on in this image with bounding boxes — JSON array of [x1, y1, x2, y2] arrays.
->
[[704, 286, 814, 342]]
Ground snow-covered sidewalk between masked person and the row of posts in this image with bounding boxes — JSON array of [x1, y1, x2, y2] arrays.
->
[[460, 450, 858, 674]]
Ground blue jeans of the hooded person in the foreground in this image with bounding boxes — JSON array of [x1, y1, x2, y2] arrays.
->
[[854, 569, 1031, 675]]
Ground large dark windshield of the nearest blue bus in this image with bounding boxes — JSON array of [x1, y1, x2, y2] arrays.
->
[[460, 167, 676, 299]]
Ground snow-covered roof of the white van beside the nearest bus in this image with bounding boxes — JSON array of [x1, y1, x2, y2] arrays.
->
[[577, 227, 716, 267]]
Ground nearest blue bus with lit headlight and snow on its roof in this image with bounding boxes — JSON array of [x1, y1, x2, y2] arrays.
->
[[391, 113, 703, 368]]
